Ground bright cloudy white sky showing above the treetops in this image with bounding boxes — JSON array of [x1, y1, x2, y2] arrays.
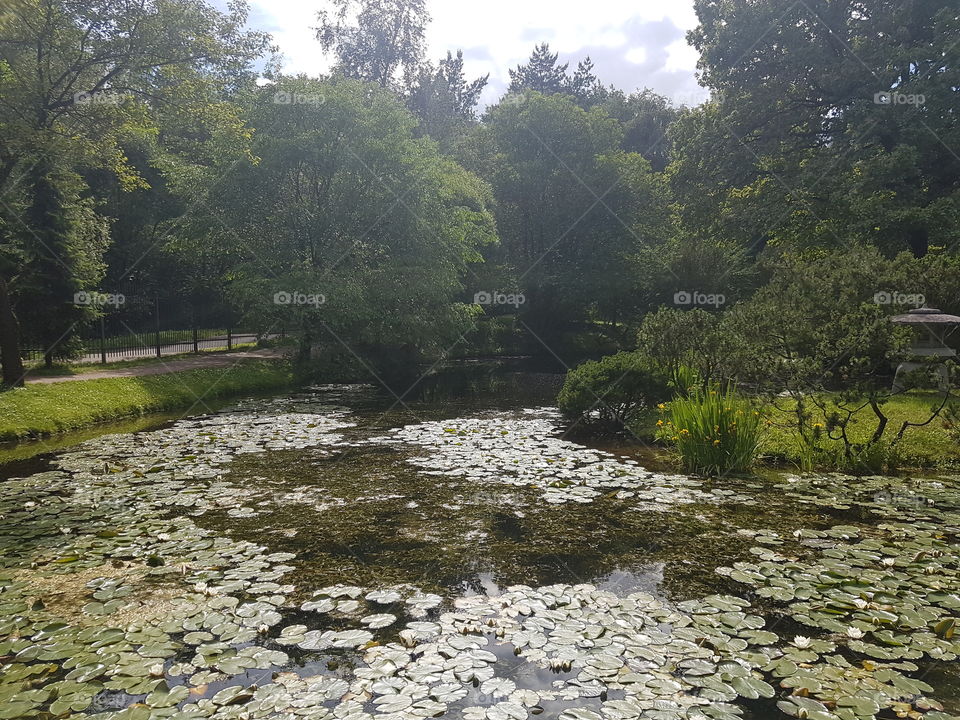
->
[[240, 0, 707, 105]]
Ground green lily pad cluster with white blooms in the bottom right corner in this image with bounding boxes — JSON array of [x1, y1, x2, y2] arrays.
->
[[717, 523, 960, 720]]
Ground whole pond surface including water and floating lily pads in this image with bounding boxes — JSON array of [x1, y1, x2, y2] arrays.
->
[[0, 366, 960, 720]]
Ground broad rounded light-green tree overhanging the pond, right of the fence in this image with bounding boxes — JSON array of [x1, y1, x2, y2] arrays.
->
[[178, 77, 496, 377]]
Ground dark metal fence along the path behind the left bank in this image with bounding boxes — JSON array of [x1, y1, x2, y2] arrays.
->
[[21, 297, 283, 363]]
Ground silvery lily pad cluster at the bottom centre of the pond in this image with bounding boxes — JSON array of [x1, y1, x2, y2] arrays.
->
[[266, 585, 780, 720]]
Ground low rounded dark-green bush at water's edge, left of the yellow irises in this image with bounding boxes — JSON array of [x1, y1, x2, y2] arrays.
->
[[557, 352, 670, 429]]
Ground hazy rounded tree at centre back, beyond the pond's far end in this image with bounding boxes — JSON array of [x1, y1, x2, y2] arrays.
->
[[463, 91, 667, 343]]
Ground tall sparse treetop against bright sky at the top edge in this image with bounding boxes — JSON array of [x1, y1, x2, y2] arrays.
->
[[316, 0, 430, 87]]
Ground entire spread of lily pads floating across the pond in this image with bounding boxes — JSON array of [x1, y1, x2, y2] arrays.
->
[[0, 388, 960, 720]]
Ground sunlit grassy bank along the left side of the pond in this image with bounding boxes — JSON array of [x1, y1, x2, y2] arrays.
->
[[0, 360, 293, 441]]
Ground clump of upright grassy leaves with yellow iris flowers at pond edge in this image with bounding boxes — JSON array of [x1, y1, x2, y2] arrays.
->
[[658, 384, 762, 475]]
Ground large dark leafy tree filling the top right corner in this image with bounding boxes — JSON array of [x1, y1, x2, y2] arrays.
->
[[677, 0, 960, 256]]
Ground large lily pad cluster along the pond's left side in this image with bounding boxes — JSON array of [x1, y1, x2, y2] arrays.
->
[[0, 400, 349, 718]]
